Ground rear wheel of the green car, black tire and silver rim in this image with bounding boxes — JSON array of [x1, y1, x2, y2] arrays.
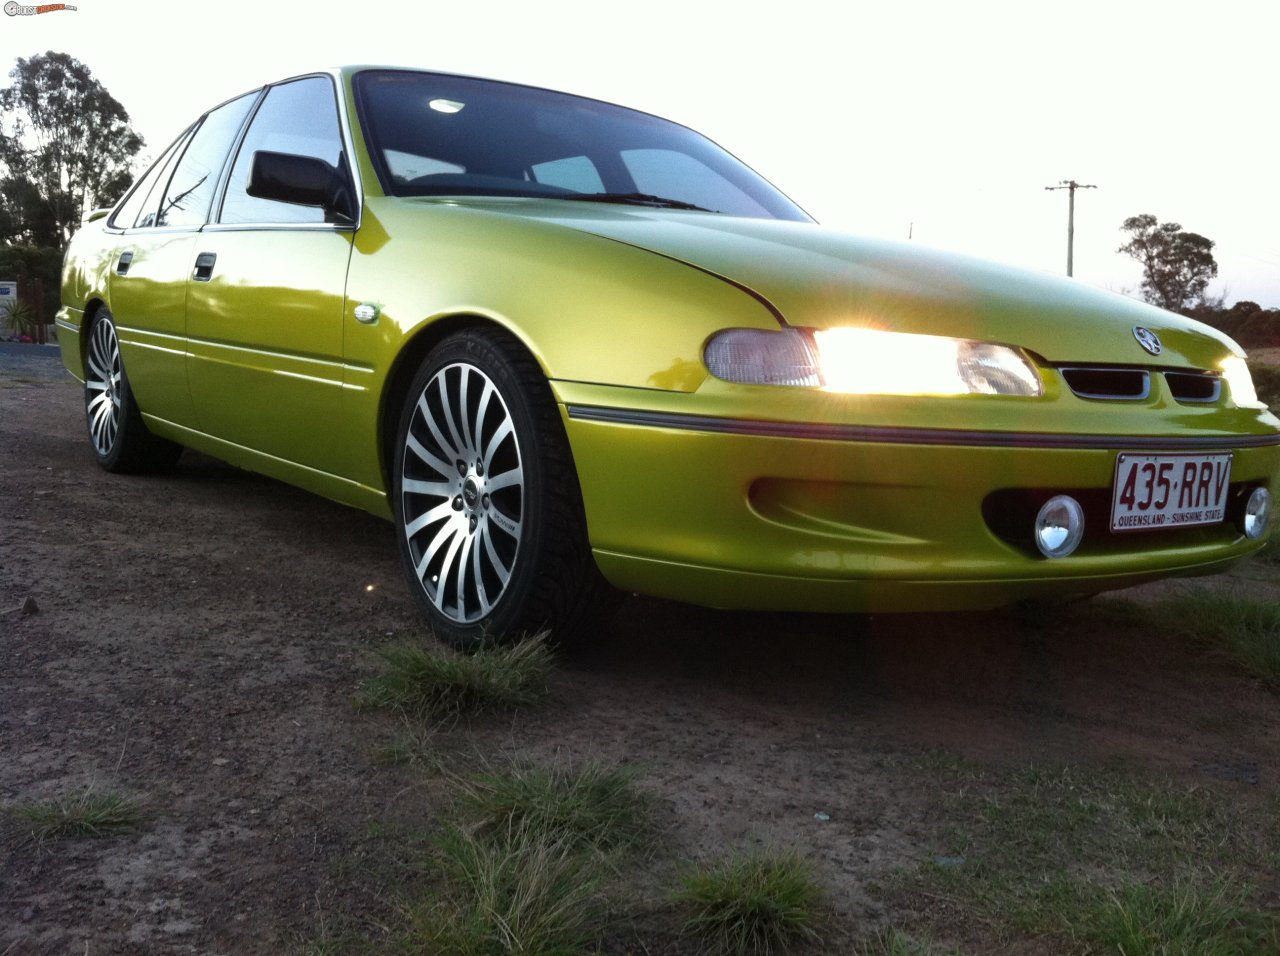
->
[[84, 308, 182, 472]]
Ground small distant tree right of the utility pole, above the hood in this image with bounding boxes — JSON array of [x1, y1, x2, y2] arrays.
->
[[1116, 214, 1217, 312]]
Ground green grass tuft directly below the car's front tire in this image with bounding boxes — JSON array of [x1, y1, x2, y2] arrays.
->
[[356, 633, 556, 719]]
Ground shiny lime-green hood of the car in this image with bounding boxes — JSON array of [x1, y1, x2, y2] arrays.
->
[[430, 200, 1239, 369]]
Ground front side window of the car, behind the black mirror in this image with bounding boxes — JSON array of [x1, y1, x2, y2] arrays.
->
[[219, 77, 346, 223]]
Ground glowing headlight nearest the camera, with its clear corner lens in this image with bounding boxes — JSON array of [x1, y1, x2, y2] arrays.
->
[[704, 328, 1042, 395]]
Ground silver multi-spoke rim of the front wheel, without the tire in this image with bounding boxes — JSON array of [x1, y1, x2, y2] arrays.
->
[[401, 362, 525, 623]]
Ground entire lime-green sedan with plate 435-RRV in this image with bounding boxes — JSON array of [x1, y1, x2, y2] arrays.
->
[[58, 67, 1280, 646]]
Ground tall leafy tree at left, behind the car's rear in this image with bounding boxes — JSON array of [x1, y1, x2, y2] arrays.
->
[[0, 51, 142, 247]]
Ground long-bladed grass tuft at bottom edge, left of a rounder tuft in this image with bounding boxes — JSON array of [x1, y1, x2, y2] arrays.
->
[[406, 822, 608, 956]]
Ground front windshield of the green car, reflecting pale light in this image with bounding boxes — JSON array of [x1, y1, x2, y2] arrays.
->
[[355, 70, 809, 221]]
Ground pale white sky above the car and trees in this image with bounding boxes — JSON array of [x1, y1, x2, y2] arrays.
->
[[0, 0, 1280, 307]]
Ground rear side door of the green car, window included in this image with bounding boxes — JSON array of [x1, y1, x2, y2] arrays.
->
[[108, 93, 257, 427]]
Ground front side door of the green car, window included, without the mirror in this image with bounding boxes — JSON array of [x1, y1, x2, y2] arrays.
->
[[187, 76, 355, 474]]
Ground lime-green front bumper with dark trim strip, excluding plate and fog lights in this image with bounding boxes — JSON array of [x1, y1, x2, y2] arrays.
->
[[563, 389, 1280, 612]]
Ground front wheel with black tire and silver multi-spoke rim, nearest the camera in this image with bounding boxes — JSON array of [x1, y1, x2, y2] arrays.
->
[[393, 329, 607, 649]]
